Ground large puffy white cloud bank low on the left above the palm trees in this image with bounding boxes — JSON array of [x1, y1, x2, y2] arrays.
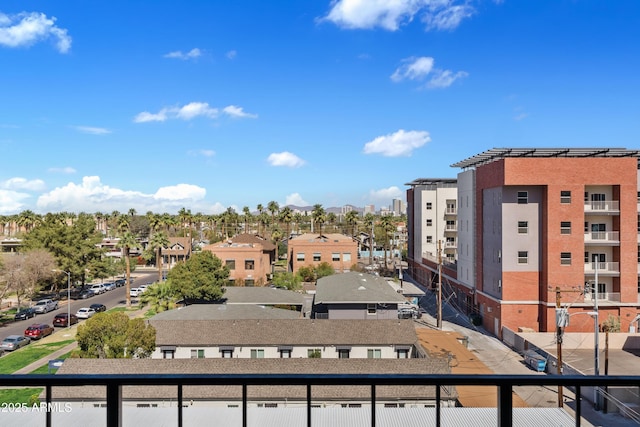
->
[[37, 176, 213, 213]]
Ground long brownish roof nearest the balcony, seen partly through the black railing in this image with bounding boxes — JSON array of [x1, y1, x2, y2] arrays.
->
[[52, 358, 457, 403]]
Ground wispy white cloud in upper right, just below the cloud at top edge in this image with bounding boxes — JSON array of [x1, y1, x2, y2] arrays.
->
[[391, 56, 469, 89]]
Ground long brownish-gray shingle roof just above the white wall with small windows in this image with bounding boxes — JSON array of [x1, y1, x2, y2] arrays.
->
[[149, 319, 418, 346]]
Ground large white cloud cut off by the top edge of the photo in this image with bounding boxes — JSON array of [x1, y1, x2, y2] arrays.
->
[[321, 0, 474, 31]]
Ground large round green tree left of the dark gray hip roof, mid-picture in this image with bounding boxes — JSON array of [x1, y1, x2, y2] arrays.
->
[[167, 251, 229, 304]]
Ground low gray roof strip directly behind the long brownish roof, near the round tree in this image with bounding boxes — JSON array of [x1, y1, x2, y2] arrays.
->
[[151, 304, 302, 320]]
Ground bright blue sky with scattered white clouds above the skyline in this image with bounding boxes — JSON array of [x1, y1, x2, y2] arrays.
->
[[0, 0, 640, 215]]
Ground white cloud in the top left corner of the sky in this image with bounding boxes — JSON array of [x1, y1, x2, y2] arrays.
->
[[0, 12, 71, 53]]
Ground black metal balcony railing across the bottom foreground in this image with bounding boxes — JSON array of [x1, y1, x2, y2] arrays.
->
[[0, 374, 640, 427]]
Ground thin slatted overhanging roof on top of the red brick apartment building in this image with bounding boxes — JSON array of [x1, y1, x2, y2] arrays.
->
[[451, 147, 640, 168]]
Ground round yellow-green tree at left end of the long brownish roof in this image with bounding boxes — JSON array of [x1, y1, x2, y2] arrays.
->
[[76, 312, 156, 359]]
